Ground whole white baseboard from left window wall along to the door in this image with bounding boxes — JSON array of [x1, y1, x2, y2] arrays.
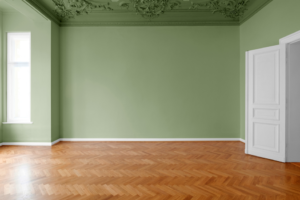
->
[[0, 138, 245, 146]]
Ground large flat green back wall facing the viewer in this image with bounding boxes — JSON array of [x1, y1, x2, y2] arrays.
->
[[60, 26, 240, 138]]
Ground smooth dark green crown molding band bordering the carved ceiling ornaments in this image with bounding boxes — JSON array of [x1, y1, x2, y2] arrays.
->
[[10, 0, 272, 27]]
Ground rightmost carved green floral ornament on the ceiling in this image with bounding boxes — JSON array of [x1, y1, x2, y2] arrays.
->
[[190, 0, 250, 20]]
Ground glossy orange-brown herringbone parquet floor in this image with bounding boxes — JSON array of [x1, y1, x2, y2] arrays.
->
[[0, 142, 300, 200]]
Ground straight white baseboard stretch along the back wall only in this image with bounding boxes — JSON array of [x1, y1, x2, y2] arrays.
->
[[60, 138, 240, 142]]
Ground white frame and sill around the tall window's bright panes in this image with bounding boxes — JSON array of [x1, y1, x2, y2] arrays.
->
[[3, 32, 32, 124]]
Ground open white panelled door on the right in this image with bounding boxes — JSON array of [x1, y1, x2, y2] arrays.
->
[[246, 45, 286, 162]]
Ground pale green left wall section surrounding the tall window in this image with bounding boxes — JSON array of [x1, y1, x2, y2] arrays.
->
[[2, 12, 51, 142]]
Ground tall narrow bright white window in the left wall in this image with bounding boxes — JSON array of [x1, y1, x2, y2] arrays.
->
[[7, 33, 31, 123]]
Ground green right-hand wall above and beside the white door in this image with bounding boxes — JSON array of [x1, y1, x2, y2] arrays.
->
[[240, 0, 300, 138]]
